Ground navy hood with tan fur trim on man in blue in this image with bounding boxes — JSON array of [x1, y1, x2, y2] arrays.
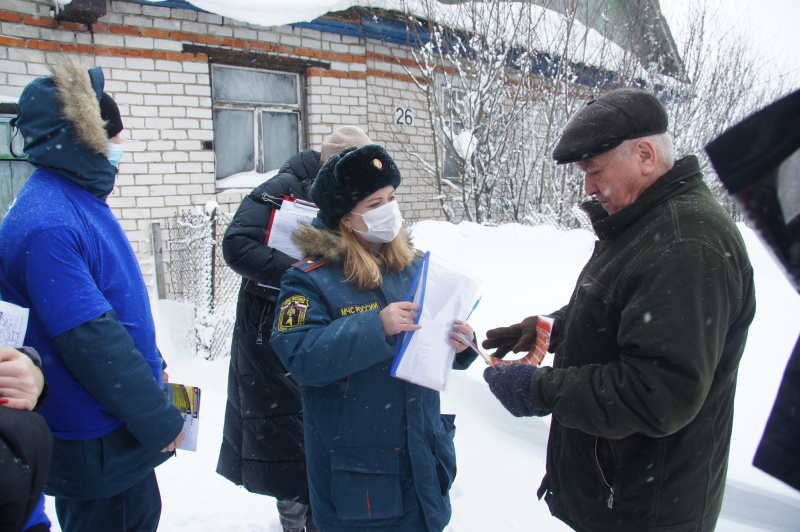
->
[[15, 57, 116, 199]]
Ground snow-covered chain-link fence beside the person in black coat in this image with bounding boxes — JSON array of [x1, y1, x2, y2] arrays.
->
[[166, 208, 241, 360]]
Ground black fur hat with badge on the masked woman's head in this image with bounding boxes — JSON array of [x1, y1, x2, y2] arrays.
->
[[311, 144, 401, 229]]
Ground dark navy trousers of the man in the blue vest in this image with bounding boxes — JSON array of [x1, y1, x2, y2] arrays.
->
[[56, 470, 161, 532]]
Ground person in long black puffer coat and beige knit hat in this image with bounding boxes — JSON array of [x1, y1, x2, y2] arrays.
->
[[217, 126, 371, 532]]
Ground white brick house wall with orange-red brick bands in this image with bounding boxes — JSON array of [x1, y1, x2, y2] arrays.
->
[[0, 0, 441, 296]]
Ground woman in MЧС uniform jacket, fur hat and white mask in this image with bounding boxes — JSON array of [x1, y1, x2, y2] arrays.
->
[[270, 145, 478, 532]]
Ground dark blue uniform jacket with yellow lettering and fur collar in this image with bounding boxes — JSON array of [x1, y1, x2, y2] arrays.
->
[[271, 220, 477, 532]]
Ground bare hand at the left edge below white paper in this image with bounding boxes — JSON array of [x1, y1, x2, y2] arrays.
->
[[0, 347, 44, 410]]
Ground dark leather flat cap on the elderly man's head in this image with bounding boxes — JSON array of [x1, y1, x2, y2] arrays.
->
[[553, 89, 668, 164]]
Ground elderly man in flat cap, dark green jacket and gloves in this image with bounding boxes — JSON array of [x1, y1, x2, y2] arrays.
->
[[483, 89, 755, 531]]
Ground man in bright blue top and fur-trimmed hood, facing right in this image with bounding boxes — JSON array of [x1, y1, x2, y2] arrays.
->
[[0, 56, 183, 532]]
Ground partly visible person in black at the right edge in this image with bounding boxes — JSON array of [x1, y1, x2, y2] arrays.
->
[[706, 90, 800, 490]]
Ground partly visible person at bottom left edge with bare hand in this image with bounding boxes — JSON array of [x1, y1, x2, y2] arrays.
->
[[0, 347, 53, 532]]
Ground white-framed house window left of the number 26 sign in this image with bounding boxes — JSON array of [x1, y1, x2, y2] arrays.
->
[[211, 65, 302, 179]]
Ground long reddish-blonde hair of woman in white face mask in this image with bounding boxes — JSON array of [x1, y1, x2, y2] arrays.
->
[[338, 222, 414, 290]]
